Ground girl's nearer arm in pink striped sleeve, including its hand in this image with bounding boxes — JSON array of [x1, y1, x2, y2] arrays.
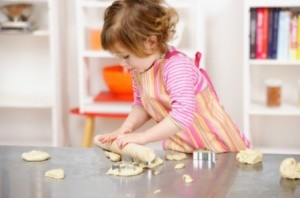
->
[[117, 57, 198, 147]]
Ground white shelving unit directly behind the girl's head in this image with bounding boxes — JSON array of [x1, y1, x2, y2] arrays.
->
[[76, 0, 204, 113]]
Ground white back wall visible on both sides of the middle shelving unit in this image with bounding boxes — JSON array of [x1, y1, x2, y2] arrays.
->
[[65, 0, 243, 146]]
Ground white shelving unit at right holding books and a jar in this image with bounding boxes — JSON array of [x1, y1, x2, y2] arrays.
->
[[243, 0, 300, 154]]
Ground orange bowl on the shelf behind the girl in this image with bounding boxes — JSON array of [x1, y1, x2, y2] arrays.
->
[[102, 65, 133, 94]]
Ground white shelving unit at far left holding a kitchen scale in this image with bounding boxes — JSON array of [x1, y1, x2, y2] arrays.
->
[[0, 0, 64, 146]]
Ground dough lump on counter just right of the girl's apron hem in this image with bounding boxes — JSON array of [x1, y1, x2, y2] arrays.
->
[[236, 149, 263, 164]]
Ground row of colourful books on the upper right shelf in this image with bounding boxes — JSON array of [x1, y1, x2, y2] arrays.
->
[[250, 8, 300, 60]]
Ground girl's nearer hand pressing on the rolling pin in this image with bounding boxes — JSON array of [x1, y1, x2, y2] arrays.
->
[[116, 133, 146, 149]]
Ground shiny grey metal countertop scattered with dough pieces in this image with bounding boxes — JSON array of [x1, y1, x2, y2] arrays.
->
[[0, 146, 300, 198]]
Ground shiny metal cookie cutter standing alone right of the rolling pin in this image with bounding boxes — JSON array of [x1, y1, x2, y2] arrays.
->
[[193, 150, 216, 169]]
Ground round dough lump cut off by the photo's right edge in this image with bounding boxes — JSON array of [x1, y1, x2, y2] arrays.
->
[[279, 158, 300, 179]]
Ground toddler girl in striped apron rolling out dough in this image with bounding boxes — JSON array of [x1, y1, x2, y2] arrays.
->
[[96, 0, 249, 153]]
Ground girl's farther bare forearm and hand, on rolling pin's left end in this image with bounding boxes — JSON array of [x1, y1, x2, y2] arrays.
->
[[98, 107, 150, 143]]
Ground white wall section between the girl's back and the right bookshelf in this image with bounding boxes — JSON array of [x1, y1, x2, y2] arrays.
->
[[204, 0, 243, 129]]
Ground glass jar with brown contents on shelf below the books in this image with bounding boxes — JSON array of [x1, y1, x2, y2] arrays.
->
[[265, 79, 282, 107]]
